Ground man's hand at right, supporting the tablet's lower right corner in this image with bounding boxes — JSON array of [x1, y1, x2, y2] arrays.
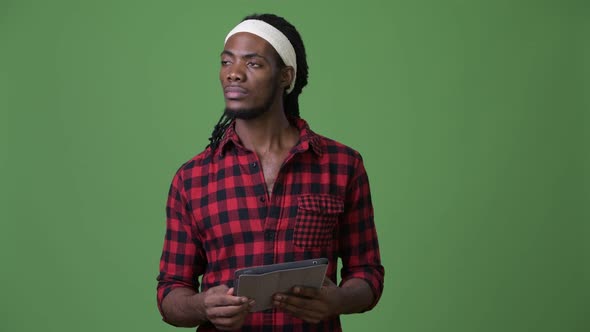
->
[[273, 277, 341, 324]]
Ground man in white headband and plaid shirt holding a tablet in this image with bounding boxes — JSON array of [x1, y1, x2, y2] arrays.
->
[[158, 14, 384, 331]]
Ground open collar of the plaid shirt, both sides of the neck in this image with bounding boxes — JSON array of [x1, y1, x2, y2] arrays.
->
[[216, 118, 323, 157]]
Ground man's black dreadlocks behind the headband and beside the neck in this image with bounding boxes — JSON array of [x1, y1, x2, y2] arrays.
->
[[207, 14, 308, 150]]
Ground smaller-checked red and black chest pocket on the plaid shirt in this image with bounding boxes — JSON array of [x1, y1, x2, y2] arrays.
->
[[293, 195, 344, 249]]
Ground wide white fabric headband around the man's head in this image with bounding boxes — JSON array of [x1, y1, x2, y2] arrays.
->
[[225, 20, 297, 93]]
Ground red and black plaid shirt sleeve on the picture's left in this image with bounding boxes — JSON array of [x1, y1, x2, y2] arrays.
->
[[157, 168, 206, 321]]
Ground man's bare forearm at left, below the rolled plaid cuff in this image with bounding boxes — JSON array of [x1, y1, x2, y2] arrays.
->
[[162, 287, 207, 327]]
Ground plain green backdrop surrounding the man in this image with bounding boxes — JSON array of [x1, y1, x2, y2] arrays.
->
[[0, 0, 590, 331]]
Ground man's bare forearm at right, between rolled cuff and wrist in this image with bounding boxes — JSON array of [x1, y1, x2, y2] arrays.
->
[[338, 278, 375, 314]]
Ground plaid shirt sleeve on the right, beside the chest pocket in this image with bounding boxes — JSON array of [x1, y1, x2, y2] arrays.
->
[[339, 156, 385, 310]]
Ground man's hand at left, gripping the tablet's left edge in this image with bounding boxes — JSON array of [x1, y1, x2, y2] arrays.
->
[[203, 285, 254, 331]]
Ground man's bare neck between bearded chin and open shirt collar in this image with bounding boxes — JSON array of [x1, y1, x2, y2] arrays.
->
[[235, 107, 299, 156]]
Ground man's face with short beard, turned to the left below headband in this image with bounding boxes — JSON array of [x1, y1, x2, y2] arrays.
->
[[219, 32, 287, 119]]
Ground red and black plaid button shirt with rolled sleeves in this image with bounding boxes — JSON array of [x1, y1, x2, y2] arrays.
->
[[157, 119, 384, 331]]
